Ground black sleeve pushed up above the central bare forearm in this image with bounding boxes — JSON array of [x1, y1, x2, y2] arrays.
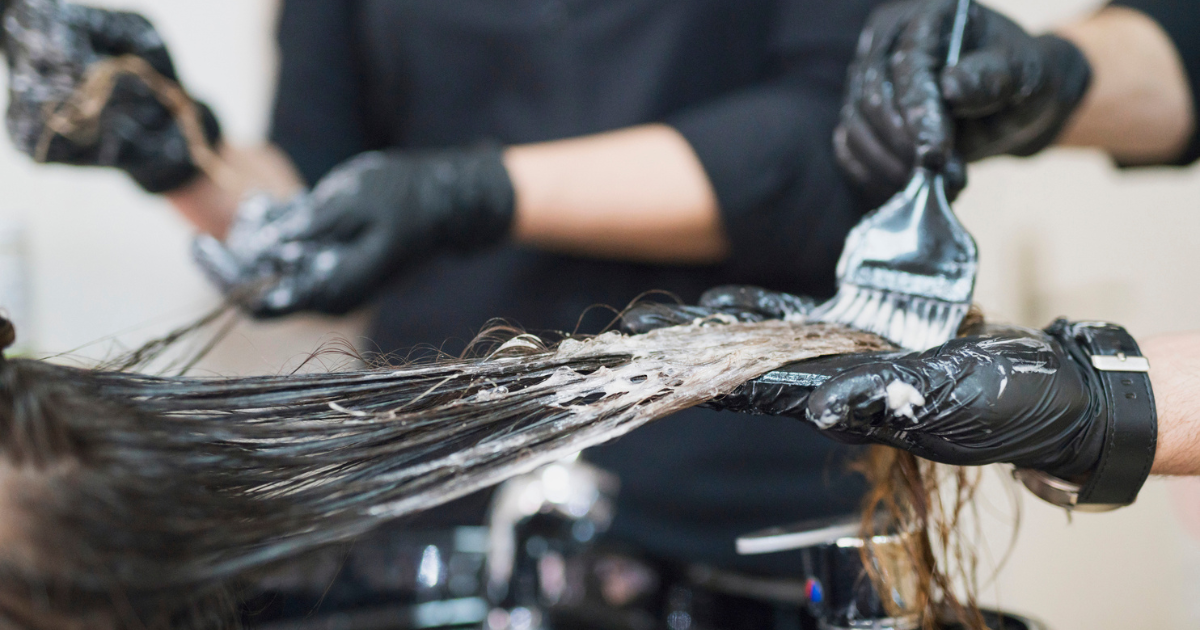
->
[[667, 0, 876, 286]]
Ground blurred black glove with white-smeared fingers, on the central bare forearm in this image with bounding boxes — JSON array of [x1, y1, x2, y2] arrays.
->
[[194, 146, 515, 317]]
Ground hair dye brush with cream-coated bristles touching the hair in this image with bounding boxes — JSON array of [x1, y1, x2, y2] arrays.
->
[[812, 0, 979, 350]]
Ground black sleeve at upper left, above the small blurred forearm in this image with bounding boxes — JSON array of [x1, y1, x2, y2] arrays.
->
[[270, 0, 371, 186]]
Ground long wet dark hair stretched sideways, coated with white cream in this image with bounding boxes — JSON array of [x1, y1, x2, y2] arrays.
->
[[0, 312, 882, 630]]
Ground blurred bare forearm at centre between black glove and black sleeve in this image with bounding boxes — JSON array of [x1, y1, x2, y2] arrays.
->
[[505, 125, 728, 264]]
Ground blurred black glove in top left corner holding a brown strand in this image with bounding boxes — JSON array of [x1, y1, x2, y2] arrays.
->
[[4, 0, 220, 193]]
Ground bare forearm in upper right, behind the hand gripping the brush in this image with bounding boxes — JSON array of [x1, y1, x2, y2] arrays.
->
[[1058, 7, 1196, 164]]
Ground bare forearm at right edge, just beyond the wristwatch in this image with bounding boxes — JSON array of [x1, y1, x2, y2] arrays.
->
[[1141, 332, 1200, 475]]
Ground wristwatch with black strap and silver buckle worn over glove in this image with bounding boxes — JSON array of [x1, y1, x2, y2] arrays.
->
[[1013, 319, 1158, 512]]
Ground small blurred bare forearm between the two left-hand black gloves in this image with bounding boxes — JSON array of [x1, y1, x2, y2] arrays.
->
[[166, 145, 304, 239]]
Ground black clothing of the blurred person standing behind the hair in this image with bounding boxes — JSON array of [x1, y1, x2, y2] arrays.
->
[[271, 0, 875, 578]]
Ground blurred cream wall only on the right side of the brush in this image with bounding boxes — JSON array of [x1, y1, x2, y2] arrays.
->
[[958, 0, 1200, 630]]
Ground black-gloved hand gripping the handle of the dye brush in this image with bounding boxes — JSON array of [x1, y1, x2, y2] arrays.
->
[[834, 0, 1091, 200]]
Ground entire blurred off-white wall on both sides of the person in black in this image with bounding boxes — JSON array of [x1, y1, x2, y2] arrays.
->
[[0, 0, 1200, 630]]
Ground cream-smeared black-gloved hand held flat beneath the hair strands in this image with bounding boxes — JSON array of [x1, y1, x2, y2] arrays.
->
[[623, 287, 1104, 479]]
